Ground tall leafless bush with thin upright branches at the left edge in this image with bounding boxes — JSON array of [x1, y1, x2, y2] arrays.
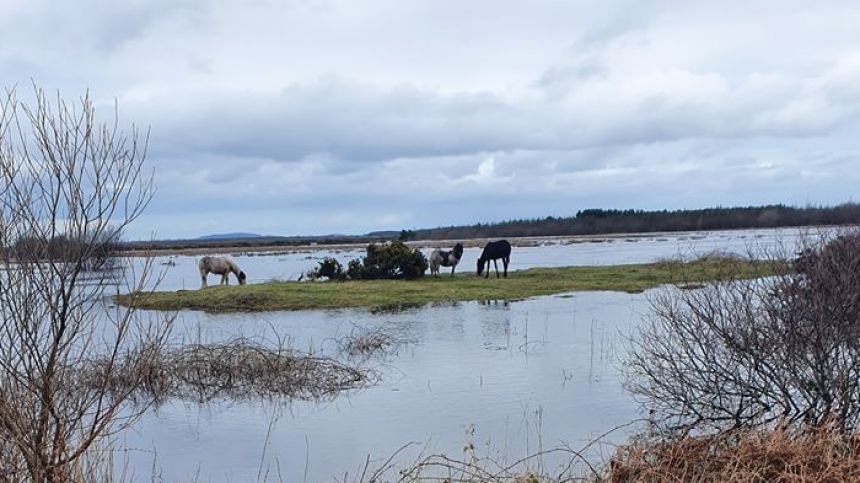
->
[[0, 85, 170, 482]]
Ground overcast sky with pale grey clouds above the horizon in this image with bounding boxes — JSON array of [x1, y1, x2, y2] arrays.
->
[[0, 0, 860, 238]]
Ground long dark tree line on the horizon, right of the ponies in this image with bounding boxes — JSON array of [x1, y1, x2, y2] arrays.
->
[[409, 203, 860, 240]]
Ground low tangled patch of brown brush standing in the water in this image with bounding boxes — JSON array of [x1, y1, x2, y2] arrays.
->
[[84, 338, 371, 402]]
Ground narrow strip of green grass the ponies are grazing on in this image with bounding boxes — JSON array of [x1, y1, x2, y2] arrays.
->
[[117, 258, 782, 312]]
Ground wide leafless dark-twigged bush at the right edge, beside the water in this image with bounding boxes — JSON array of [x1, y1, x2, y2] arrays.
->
[[627, 232, 860, 431]]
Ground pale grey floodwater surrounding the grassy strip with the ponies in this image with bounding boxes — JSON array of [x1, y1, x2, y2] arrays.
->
[[122, 230, 812, 482]]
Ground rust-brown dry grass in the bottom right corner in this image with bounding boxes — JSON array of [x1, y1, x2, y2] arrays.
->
[[606, 425, 860, 483]]
